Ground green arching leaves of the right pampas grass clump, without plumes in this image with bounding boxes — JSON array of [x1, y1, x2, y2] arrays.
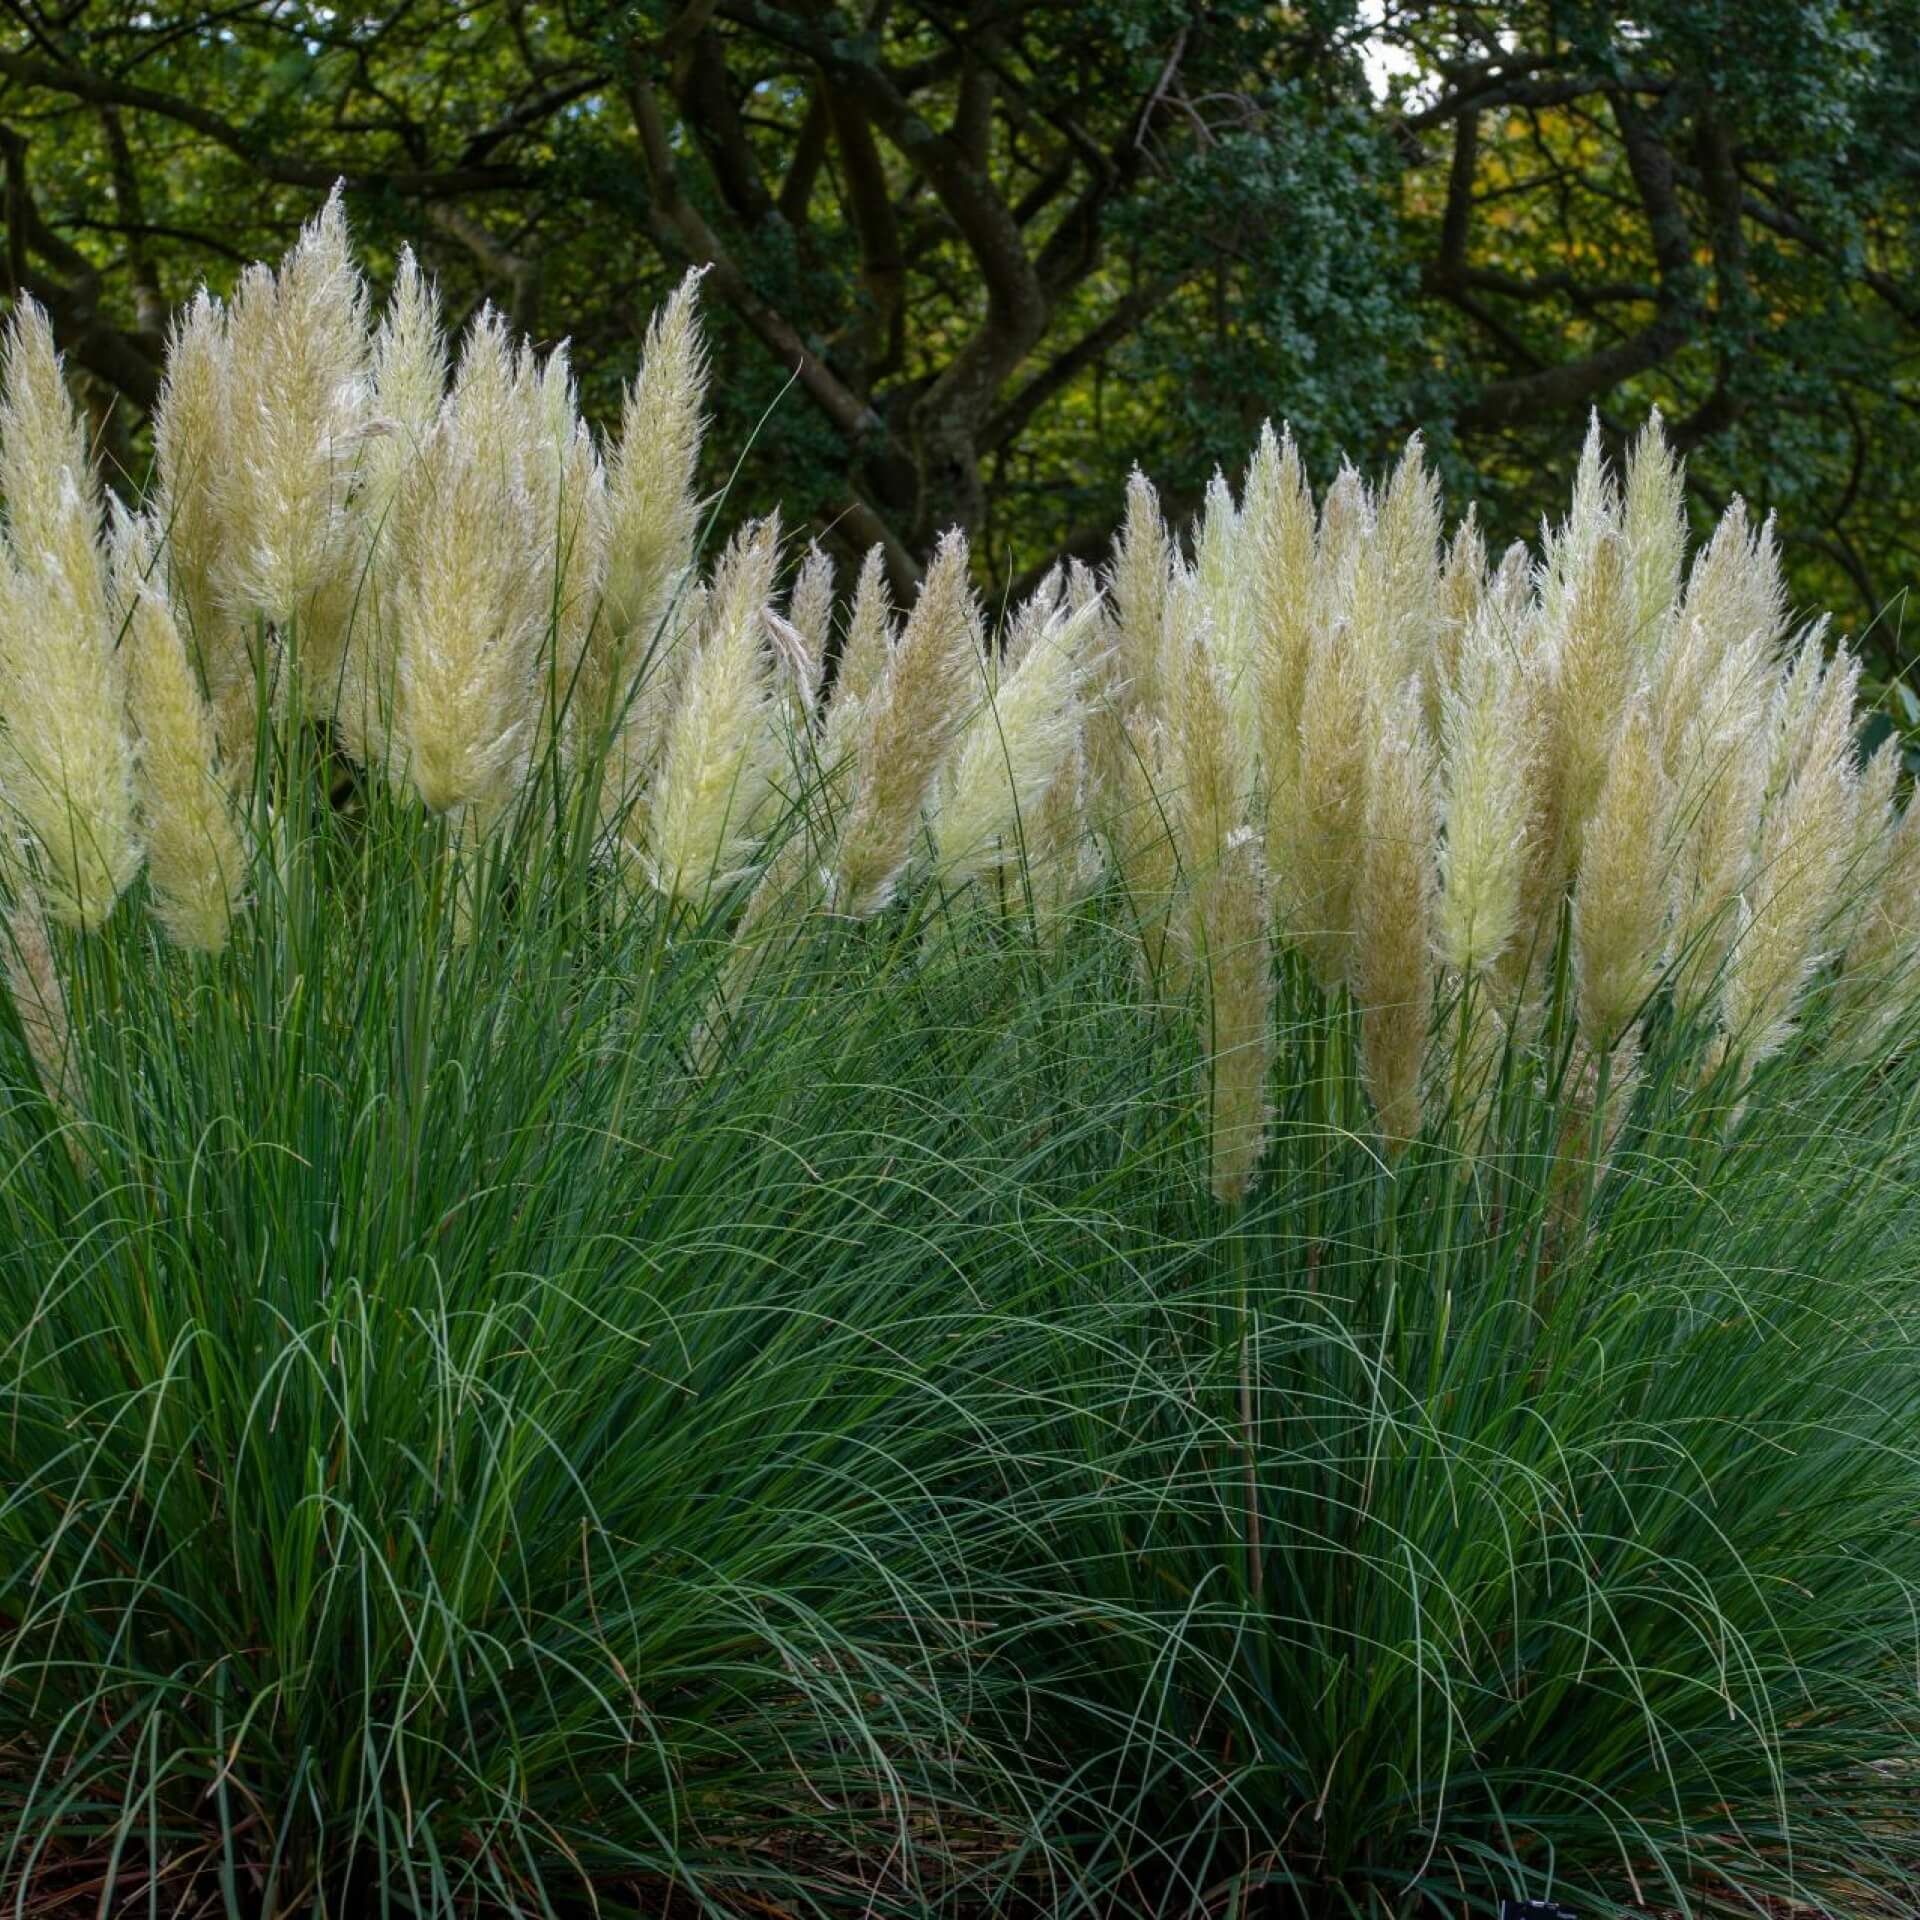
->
[[983, 1044, 1920, 1914]]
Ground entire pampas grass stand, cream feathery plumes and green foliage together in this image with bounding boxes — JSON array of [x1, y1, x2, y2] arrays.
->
[[0, 204, 1920, 1920]]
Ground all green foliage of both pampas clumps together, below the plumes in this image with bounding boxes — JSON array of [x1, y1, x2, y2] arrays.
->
[[11, 744, 1920, 1914]]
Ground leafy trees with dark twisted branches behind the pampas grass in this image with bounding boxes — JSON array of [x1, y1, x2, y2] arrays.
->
[[0, 0, 1920, 645]]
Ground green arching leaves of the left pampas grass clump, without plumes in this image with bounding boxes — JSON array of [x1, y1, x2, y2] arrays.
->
[[0, 771, 1113, 1912]]
